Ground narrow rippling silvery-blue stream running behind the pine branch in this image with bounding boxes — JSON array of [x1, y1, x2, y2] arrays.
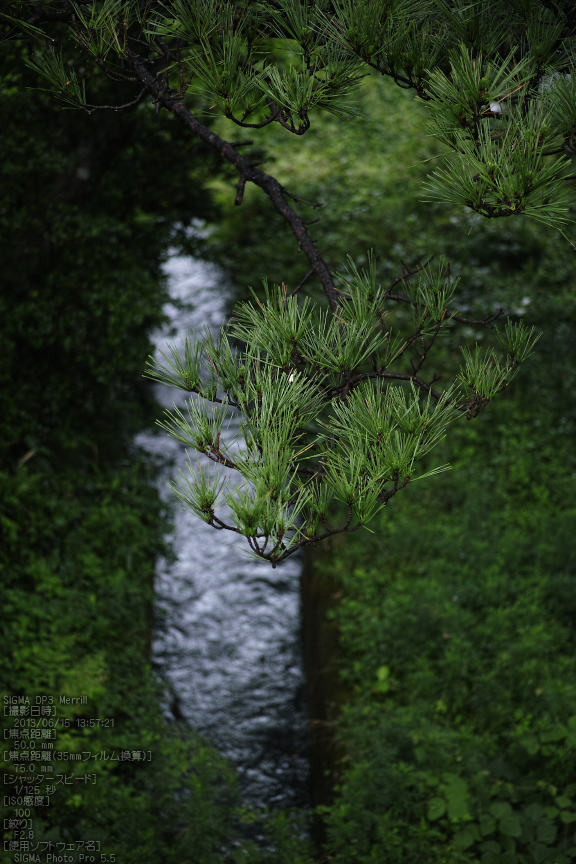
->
[[137, 250, 309, 807]]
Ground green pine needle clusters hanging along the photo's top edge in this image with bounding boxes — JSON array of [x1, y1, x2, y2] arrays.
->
[[9, 0, 575, 228]]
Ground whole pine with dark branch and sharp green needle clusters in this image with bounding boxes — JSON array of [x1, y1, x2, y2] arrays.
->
[[5, 0, 576, 566]]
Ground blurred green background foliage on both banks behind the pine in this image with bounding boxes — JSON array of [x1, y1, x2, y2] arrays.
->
[[0, 28, 576, 864]]
